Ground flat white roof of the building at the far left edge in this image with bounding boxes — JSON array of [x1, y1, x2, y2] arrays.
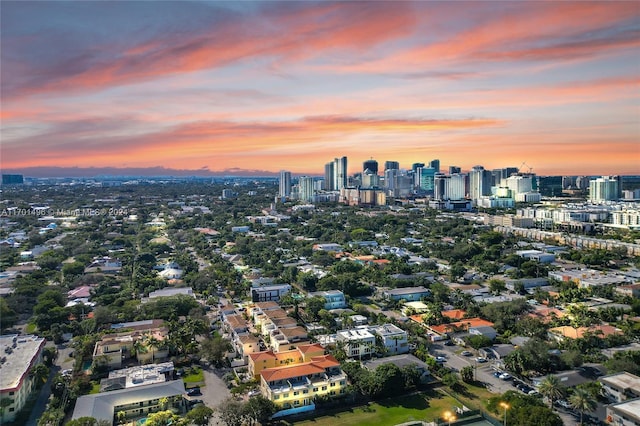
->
[[0, 334, 44, 391]]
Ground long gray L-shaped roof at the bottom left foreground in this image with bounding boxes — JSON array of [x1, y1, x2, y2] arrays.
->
[[72, 380, 184, 424]]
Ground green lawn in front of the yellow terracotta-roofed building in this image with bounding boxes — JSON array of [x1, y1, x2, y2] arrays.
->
[[290, 392, 460, 426]]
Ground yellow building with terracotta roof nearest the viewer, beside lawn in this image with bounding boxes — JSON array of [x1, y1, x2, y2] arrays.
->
[[260, 355, 347, 417]]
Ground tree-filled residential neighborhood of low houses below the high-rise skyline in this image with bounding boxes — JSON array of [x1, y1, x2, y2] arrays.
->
[[0, 179, 640, 426]]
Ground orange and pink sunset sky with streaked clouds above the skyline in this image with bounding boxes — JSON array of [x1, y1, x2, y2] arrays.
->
[[0, 0, 640, 175]]
